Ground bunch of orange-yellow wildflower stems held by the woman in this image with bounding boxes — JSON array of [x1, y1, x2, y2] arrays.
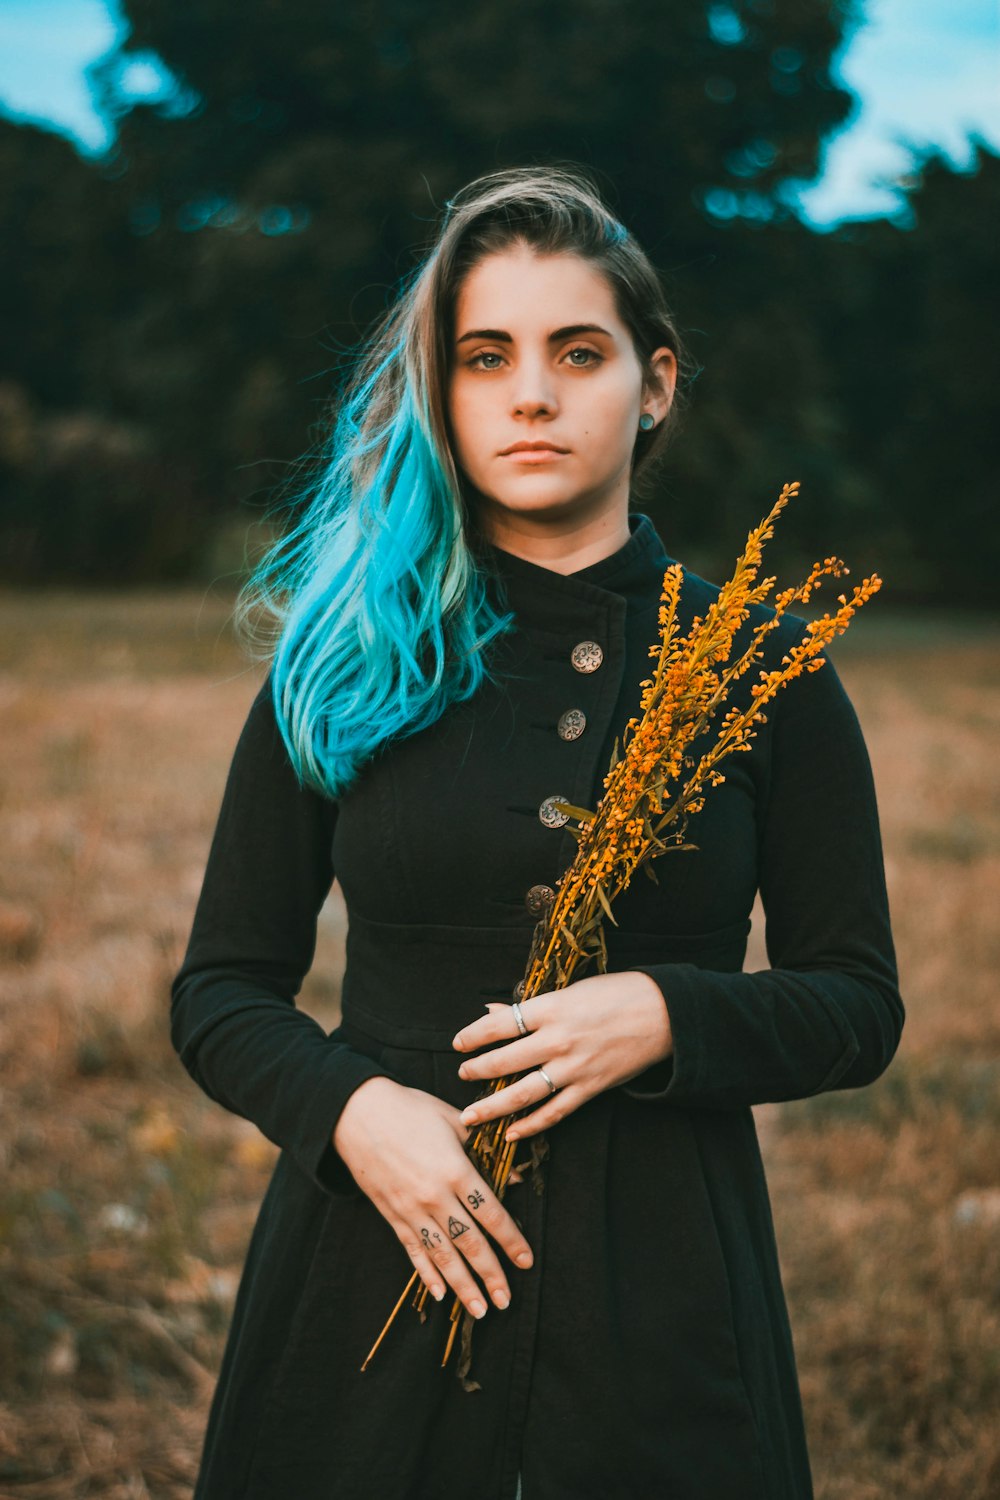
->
[[361, 482, 882, 1391]]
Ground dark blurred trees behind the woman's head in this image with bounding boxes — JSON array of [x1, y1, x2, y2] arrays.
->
[[0, 0, 999, 600]]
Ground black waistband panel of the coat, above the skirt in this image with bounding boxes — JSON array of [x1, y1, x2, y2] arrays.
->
[[342, 912, 750, 1052]]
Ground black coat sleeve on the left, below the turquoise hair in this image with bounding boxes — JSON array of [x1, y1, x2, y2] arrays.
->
[[171, 678, 385, 1193]]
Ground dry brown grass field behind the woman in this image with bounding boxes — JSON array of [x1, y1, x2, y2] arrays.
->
[[0, 593, 1000, 1500]]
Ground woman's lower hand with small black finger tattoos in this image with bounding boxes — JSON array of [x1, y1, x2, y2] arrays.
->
[[333, 1076, 534, 1317]]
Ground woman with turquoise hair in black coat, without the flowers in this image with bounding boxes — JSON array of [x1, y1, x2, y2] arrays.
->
[[172, 170, 903, 1500]]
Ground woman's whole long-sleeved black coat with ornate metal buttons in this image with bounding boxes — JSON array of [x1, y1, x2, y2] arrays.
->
[[172, 515, 903, 1500]]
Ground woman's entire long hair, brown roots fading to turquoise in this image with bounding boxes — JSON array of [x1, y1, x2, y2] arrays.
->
[[235, 167, 685, 798]]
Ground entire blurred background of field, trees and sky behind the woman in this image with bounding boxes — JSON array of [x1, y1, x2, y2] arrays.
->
[[0, 0, 1000, 1500]]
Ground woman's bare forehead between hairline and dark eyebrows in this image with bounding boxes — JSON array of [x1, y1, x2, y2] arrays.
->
[[456, 245, 625, 336]]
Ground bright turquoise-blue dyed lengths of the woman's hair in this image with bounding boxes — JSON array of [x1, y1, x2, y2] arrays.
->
[[233, 301, 514, 798]]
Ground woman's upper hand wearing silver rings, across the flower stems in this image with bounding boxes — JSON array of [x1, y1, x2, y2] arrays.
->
[[451, 969, 673, 1140]]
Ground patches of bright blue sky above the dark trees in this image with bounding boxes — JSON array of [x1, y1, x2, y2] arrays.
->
[[0, 0, 1000, 228]]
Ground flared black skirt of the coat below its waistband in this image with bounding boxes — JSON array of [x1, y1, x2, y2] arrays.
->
[[195, 996, 811, 1500]]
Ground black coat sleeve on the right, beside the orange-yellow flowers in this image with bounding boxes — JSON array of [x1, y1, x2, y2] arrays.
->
[[622, 627, 904, 1109]]
